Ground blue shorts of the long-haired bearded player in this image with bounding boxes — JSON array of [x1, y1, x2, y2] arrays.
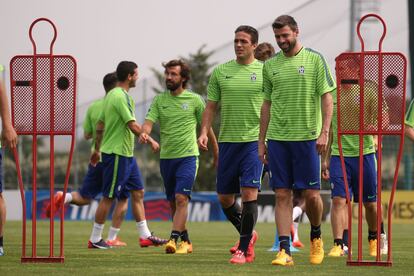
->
[[160, 156, 198, 201]]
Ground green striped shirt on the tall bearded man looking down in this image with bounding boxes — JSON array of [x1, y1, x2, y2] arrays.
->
[[263, 48, 336, 141]]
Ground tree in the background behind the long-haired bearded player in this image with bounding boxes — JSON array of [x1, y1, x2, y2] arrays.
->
[[151, 44, 219, 191]]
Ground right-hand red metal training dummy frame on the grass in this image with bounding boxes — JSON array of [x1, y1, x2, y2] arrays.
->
[[336, 14, 407, 266]]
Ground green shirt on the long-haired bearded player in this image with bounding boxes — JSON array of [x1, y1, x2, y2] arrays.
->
[[145, 90, 205, 159]]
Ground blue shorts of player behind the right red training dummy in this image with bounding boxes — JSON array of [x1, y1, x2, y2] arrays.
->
[[329, 153, 377, 202]]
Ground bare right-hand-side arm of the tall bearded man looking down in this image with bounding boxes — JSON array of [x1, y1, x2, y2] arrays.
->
[[316, 92, 333, 154]]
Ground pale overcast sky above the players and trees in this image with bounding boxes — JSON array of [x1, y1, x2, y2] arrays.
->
[[0, 0, 408, 110]]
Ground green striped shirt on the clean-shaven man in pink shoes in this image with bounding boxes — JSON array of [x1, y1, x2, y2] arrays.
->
[[207, 60, 263, 142]]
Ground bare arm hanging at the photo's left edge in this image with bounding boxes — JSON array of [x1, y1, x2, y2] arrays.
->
[[0, 82, 17, 149]]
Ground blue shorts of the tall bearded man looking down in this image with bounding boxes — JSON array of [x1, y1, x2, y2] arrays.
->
[[267, 140, 321, 190]]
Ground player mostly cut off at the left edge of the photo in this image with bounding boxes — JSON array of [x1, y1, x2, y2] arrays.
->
[[0, 80, 17, 256]]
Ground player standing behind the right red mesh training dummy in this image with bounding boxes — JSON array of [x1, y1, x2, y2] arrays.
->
[[322, 57, 389, 257]]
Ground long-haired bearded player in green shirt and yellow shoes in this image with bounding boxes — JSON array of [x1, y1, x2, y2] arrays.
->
[[140, 60, 218, 254]]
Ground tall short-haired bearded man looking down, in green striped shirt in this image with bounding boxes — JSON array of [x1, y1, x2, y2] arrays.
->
[[259, 15, 335, 265]]
